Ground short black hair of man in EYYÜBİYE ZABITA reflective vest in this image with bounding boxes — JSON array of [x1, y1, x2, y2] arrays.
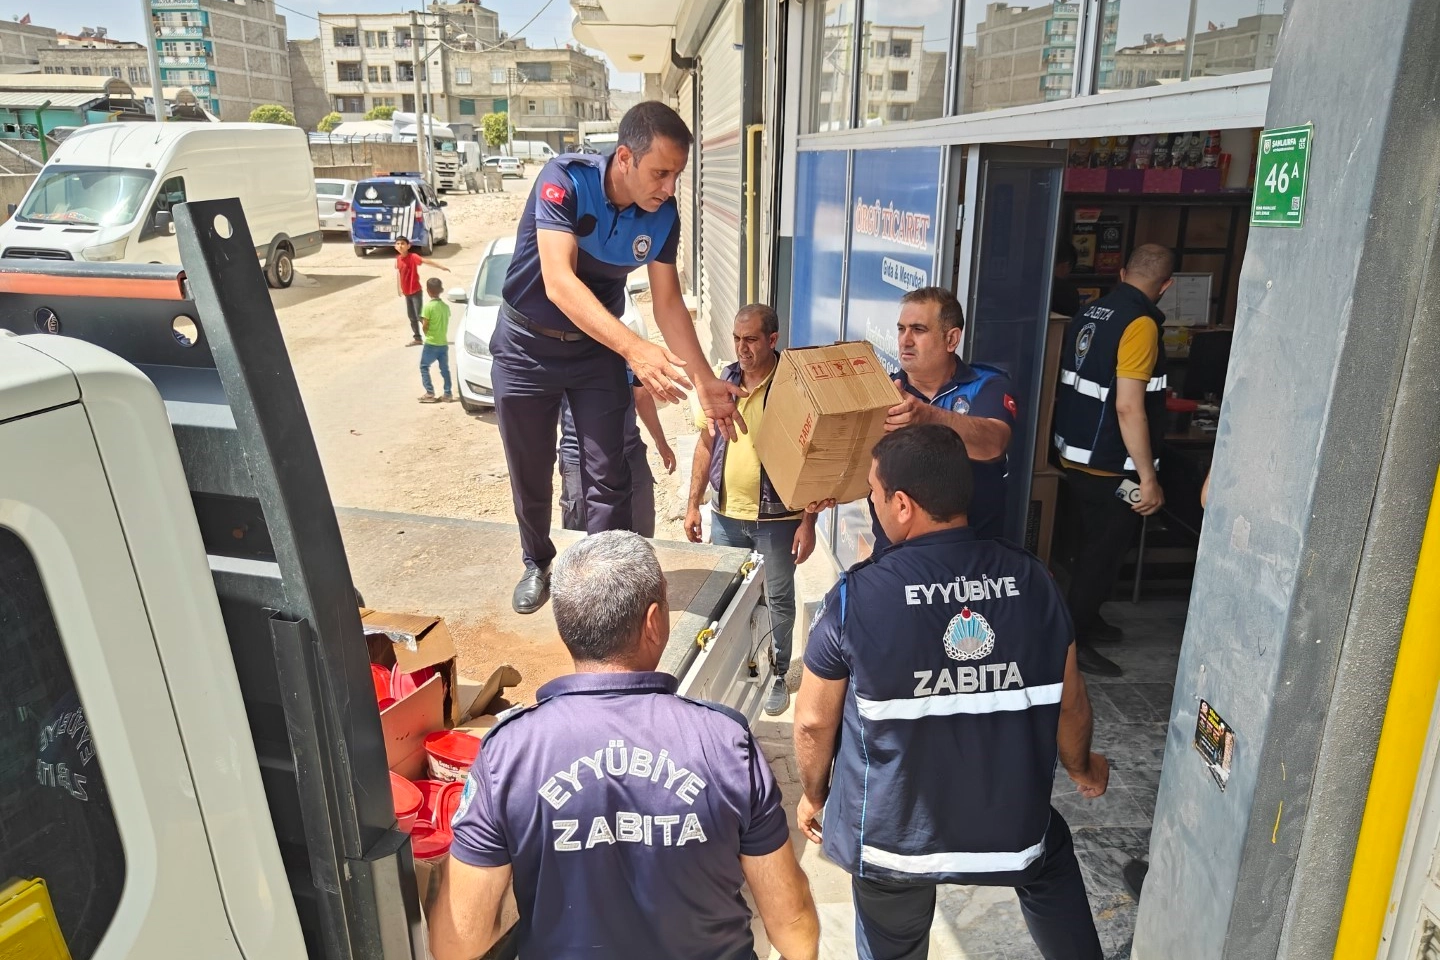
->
[[871, 423, 975, 522]]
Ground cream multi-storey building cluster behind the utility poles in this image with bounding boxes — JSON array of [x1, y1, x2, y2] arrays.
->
[[320, 4, 609, 150]]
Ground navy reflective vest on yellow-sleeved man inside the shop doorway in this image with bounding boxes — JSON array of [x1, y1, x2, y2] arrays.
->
[[1054, 284, 1168, 474]]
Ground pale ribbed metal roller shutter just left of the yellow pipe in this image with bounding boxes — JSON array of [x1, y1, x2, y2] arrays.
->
[[698, 0, 744, 358]]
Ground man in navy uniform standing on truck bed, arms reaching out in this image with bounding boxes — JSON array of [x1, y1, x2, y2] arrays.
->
[[490, 101, 744, 613]]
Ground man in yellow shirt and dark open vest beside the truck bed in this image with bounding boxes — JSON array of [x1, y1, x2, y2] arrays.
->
[[685, 304, 815, 717]]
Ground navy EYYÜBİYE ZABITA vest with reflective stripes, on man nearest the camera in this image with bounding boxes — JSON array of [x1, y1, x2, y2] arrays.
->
[[824, 528, 1073, 885]]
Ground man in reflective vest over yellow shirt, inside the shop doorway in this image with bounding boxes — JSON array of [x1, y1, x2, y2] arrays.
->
[[1054, 243, 1174, 676]]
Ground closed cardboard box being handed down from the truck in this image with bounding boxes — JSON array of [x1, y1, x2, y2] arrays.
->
[[755, 341, 899, 510]]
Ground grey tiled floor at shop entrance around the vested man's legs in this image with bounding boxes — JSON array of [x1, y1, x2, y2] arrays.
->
[[755, 602, 1185, 960]]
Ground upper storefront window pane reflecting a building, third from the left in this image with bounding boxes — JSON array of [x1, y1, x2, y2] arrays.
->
[[960, 0, 1082, 114]]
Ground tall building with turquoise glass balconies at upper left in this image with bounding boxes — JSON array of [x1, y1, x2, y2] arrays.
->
[[150, 0, 294, 121]]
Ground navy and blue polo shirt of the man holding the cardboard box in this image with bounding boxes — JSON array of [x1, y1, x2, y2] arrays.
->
[[870, 357, 1018, 553]]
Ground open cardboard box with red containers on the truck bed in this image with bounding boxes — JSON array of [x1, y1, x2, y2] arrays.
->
[[360, 607, 462, 780]]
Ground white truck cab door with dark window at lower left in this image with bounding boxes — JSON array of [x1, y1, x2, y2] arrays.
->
[[0, 403, 240, 960]]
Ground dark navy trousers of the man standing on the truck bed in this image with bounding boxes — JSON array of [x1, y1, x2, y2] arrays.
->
[[490, 317, 634, 567]]
